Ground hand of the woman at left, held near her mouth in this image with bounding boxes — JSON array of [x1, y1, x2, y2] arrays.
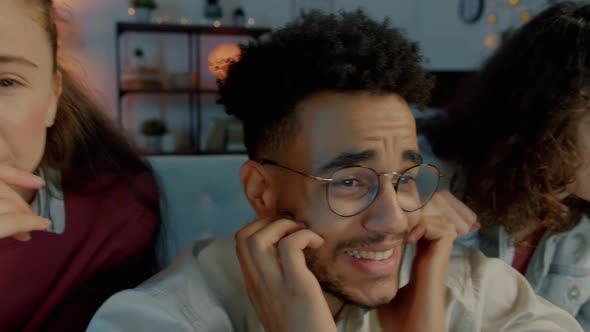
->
[[0, 164, 51, 241]]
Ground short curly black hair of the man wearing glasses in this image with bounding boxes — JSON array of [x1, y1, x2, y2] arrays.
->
[[219, 10, 433, 159]]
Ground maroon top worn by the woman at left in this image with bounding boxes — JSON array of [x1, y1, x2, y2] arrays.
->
[[0, 175, 159, 331]]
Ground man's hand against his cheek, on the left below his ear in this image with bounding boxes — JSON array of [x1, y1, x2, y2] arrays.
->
[[236, 218, 336, 332]]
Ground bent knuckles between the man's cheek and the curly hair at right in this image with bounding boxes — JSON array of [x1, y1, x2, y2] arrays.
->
[[422, 190, 481, 236]]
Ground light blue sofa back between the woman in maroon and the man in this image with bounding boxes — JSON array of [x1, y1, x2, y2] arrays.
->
[[148, 154, 254, 267]]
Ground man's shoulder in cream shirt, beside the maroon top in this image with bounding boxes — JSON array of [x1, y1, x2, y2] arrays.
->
[[90, 238, 249, 331]]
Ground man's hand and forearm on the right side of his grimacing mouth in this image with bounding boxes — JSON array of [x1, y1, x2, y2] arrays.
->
[[379, 216, 457, 332]]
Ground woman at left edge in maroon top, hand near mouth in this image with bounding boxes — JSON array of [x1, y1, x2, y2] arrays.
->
[[0, 0, 159, 331]]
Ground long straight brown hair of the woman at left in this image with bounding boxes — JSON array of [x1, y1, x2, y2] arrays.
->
[[28, 0, 161, 268]]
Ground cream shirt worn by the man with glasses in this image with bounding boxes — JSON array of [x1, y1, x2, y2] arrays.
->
[[88, 239, 582, 332]]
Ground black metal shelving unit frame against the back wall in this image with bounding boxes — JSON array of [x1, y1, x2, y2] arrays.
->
[[115, 22, 270, 154]]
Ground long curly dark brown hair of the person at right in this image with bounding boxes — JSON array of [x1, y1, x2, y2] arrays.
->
[[420, 2, 590, 234]]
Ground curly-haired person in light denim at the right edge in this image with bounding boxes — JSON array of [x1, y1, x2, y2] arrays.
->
[[422, 2, 590, 331]]
